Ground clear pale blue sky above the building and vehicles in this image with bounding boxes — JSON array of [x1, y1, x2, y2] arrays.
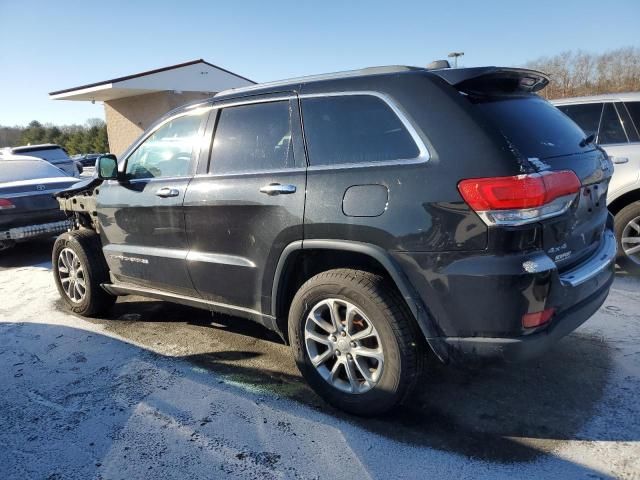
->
[[0, 0, 640, 125]]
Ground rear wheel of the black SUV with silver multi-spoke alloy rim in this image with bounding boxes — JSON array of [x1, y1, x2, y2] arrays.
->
[[289, 269, 424, 416]]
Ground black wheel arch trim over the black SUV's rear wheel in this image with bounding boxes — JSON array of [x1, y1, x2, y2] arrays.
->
[[271, 239, 448, 361]]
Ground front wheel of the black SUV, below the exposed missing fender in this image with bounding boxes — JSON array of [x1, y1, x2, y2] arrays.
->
[[52, 230, 116, 316]]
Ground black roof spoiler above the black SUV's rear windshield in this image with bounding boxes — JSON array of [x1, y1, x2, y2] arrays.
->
[[431, 67, 549, 95]]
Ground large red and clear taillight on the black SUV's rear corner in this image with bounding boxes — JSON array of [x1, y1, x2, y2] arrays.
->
[[458, 170, 581, 225]]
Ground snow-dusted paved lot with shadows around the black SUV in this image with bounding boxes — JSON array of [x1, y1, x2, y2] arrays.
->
[[0, 242, 640, 479]]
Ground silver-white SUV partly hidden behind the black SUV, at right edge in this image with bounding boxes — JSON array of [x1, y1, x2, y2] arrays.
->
[[551, 93, 640, 273]]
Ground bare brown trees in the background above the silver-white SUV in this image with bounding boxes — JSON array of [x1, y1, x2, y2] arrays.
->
[[526, 47, 640, 98]]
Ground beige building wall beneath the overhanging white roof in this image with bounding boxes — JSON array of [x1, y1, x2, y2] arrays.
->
[[104, 91, 213, 156]]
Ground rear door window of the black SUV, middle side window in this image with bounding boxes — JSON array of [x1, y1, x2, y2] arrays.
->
[[210, 100, 295, 174]]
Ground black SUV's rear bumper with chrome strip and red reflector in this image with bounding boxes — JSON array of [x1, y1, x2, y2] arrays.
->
[[396, 228, 616, 362]]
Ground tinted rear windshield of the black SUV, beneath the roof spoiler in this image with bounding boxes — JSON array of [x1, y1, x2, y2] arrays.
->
[[469, 95, 594, 158]]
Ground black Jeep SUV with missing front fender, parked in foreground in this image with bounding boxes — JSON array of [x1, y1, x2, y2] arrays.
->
[[53, 67, 616, 415]]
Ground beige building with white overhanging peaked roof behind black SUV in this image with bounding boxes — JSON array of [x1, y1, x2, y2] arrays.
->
[[49, 59, 255, 155]]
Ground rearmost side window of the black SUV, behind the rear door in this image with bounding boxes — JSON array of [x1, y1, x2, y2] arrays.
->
[[302, 95, 420, 166]]
